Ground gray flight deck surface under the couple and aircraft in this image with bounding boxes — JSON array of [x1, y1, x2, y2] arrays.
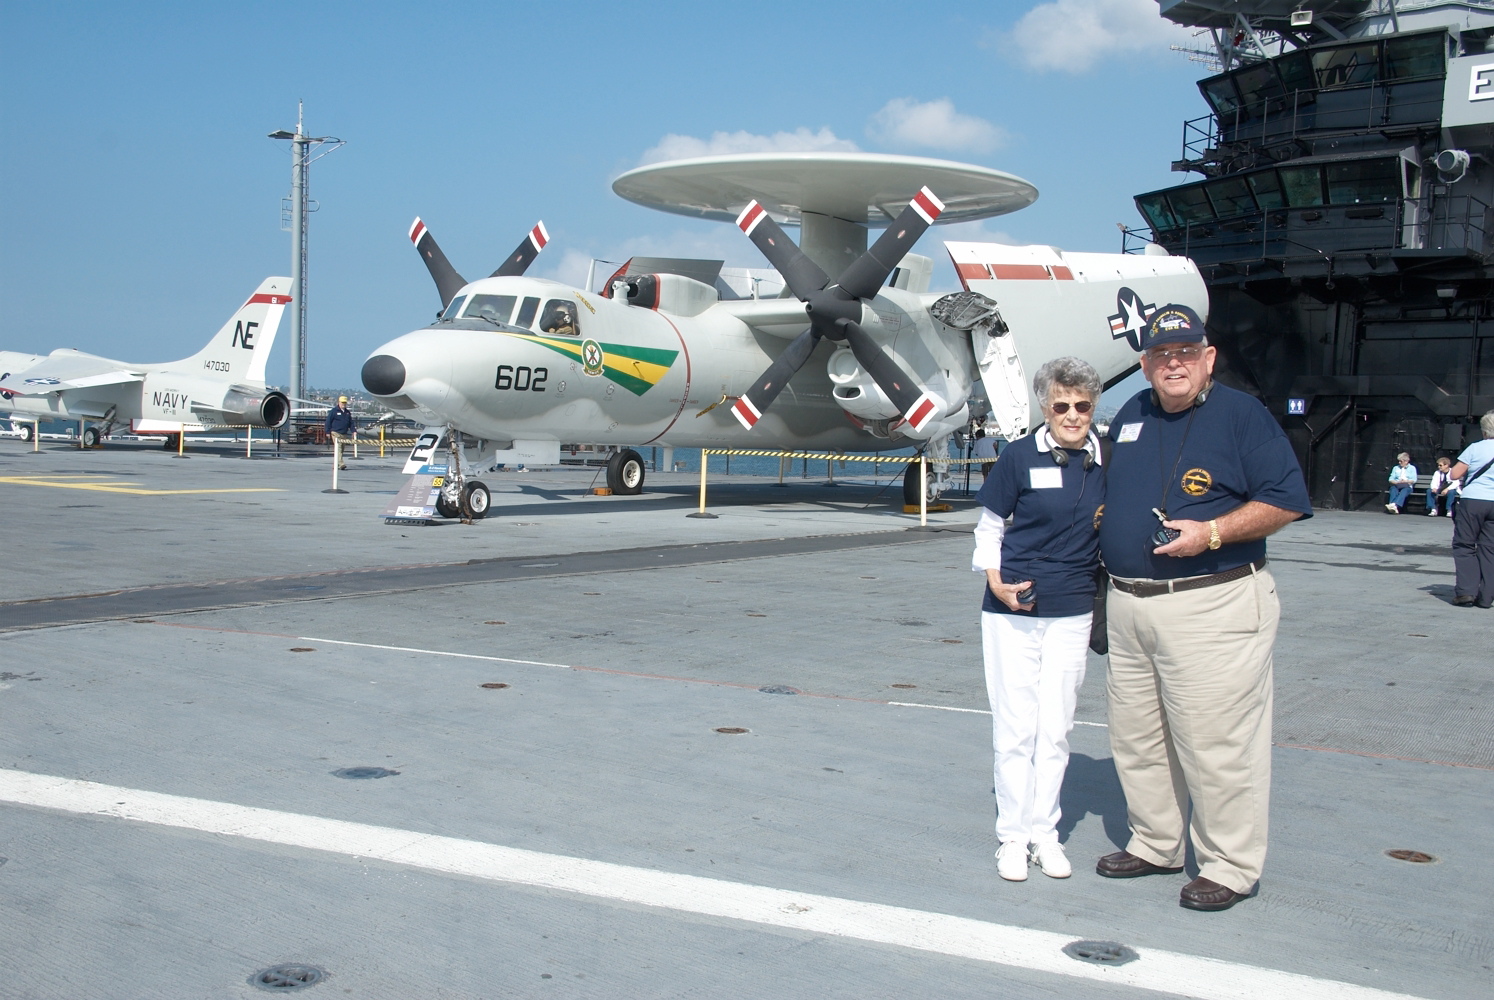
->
[[0, 441, 1494, 999]]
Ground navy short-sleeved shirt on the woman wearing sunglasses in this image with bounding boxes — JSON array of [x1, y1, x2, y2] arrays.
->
[[976, 433, 1106, 617]]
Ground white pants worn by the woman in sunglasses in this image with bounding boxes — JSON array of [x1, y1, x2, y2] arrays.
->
[[980, 611, 1091, 843]]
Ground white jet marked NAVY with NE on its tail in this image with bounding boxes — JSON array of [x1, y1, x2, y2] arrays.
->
[[0, 278, 290, 447]]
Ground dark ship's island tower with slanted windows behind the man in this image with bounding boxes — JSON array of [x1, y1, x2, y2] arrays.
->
[[1126, 0, 1494, 508]]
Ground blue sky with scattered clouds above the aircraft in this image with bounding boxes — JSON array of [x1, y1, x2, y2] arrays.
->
[[0, 0, 1206, 387]]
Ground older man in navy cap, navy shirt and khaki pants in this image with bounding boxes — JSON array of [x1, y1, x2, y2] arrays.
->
[[1095, 305, 1312, 910]]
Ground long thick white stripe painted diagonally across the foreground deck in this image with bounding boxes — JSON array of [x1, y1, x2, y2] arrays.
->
[[0, 768, 1416, 1000]]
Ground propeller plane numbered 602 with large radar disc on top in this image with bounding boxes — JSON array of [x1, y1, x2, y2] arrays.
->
[[363, 154, 1209, 510]]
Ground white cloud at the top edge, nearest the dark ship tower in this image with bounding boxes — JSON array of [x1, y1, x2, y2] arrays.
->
[[1001, 0, 1192, 73]]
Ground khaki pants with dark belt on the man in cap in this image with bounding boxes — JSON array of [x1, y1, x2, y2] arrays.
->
[[1106, 570, 1280, 892]]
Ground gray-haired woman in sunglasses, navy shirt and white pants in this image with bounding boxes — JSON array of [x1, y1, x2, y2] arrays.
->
[[973, 357, 1104, 882]]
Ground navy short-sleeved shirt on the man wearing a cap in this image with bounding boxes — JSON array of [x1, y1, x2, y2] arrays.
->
[[1100, 384, 1312, 580]]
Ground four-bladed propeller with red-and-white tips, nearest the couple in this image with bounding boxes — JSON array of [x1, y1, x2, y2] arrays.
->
[[726, 187, 944, 430]]
